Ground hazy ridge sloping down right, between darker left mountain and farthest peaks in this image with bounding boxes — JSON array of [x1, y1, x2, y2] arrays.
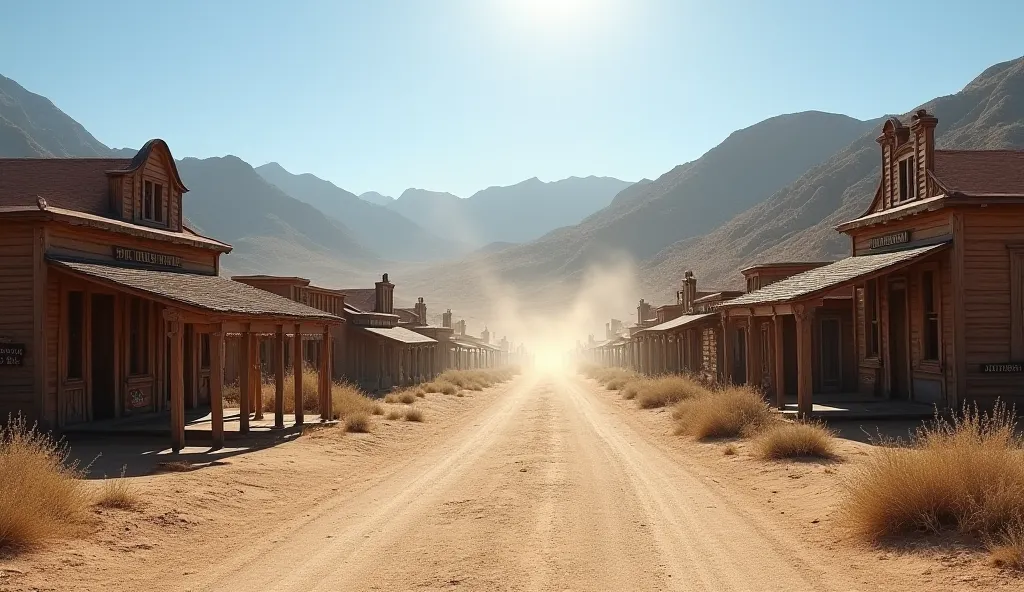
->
[[256, 163, 465, 261]]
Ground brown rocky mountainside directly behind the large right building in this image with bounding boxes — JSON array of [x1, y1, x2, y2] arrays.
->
[[642, 58, 1024, 299]]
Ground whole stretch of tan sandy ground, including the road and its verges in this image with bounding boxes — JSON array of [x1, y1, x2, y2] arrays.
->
[[0, 376, 1024, 591]]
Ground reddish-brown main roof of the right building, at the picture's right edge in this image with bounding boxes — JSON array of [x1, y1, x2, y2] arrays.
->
[[934, 151, 1024, 197]]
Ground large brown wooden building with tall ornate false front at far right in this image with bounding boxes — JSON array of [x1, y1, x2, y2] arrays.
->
[[723, 111, 1024, 415]]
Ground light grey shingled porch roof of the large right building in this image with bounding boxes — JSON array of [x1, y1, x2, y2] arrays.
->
[[722, 243, 948, 308]]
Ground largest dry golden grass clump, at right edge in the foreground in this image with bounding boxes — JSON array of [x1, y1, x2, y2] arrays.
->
[[844, 404, 1024, 544]]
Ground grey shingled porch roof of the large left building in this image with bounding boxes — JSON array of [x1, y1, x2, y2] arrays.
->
[[47, 257, 342, 323]]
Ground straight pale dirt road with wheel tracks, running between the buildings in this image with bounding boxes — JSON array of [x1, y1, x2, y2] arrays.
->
[[151, 377, 879, 591]]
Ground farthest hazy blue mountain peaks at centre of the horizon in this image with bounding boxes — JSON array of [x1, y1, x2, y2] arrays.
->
[[388, 176, 631, 247]]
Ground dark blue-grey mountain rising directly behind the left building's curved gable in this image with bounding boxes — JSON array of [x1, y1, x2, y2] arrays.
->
[[178, 156, 376, 279]]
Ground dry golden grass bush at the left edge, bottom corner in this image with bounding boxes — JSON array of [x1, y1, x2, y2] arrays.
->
[[0, 416, 90, 550]]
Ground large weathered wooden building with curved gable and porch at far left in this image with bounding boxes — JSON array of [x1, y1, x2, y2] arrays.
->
[[0, 139, 342, 450]]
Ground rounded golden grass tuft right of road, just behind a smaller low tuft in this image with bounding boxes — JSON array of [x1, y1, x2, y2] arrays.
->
[[672, 386, 773, 439]]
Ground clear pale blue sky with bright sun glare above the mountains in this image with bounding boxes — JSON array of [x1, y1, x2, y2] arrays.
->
[[0, 0, 1024, 197]]
